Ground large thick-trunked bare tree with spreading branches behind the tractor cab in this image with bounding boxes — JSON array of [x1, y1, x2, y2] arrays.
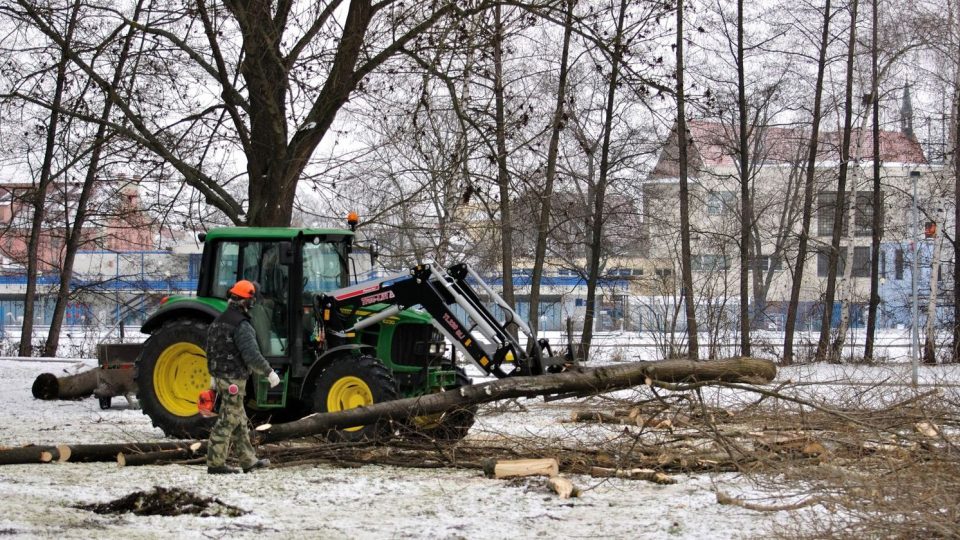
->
[[11, 0, 520, 225]]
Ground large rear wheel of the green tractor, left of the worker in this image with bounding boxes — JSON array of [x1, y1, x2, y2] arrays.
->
[[136, 319, 216, 439]]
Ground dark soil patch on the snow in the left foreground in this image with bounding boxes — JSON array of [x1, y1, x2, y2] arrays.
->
[[76, 486, 247, 517]]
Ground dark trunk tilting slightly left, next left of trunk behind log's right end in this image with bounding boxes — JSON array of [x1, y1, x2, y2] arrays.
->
[[677, 0, 700, 360]]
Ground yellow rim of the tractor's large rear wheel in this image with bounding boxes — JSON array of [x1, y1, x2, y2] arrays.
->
[[153, 342, 210, 416]]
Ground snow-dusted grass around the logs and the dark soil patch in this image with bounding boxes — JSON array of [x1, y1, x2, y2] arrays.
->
[[0, 360, 804, 539]]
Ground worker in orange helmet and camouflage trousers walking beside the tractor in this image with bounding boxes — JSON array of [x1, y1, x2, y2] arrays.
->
[[206, 280, 280, 474]]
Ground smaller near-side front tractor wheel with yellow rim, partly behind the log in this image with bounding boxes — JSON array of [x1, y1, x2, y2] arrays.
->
[[313, 356, 398, 442]]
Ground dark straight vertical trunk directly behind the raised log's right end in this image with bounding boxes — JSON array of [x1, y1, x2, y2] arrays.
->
[[737, 0, 753, 356]]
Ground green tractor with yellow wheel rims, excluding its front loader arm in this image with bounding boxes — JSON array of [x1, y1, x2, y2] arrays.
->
[[135, 227, 475, 440]]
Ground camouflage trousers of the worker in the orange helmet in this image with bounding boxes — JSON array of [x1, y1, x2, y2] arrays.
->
[[207, 379, 257, 468]]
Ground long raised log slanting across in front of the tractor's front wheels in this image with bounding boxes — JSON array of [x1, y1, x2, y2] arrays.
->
[[257, 358, 777, 444]]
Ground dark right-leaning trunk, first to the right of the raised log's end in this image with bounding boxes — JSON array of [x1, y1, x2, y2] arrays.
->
[[783, 0, 830, 365]]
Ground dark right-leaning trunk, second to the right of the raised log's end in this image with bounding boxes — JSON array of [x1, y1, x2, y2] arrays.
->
[[817, 0, 859, 360]]
